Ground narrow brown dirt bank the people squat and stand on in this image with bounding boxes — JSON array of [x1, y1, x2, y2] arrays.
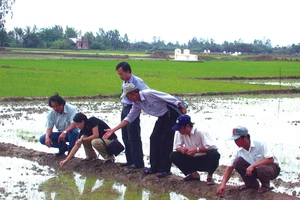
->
[[0, 143, 298, 200]]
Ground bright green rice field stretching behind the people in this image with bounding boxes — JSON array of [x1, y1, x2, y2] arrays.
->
[[0, 59, 300, 97]]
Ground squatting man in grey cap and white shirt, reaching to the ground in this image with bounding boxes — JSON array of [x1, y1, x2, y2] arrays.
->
[[217, 126, 280, 196]]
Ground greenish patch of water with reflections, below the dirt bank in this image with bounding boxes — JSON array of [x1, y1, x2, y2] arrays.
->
[[40, 171, 195, 200]]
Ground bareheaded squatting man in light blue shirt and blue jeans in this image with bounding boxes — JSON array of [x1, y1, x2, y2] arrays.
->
[[40, 94, 78, 156]]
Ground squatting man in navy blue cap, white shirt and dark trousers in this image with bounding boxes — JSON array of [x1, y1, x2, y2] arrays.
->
[[170, 115, 220, 185]]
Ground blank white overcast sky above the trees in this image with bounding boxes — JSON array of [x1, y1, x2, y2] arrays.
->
[[5, 0, 300, 46]]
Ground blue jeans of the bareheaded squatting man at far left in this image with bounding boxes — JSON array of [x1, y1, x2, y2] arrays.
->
[[40, 128, 78, 151]]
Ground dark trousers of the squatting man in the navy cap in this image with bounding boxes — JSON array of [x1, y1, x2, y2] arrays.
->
[[170, 149, 220, 175]]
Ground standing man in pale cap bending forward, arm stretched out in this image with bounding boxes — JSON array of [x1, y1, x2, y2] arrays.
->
[[103, 83, 186, 177]]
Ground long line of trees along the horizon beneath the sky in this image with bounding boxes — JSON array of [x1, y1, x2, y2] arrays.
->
[[0, 25, 300, 54]]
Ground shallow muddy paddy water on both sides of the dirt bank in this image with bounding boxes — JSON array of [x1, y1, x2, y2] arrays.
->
[[0, 96, 300, 199]]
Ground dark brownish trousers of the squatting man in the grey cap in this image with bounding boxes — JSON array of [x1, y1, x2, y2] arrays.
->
[[233, 157, 280, 187]]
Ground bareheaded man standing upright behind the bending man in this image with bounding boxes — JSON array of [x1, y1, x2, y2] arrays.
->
[[116, 62, 149, 169]]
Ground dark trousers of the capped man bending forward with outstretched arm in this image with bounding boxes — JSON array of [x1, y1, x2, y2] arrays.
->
[[150, 110, 179, 172]]
